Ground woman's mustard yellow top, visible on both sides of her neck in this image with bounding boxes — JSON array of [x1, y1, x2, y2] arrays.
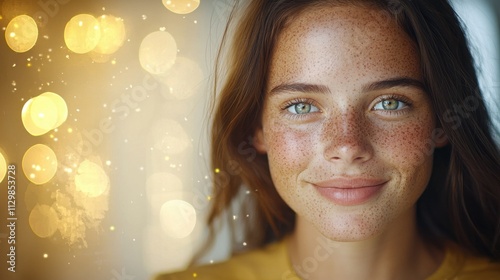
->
[[156, 238, 500, 280]]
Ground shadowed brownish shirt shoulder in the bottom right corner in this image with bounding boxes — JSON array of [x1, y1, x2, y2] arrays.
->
[[428, 244, 500, 280]]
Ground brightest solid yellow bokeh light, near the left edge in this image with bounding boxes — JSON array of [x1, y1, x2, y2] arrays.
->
[[21, 92, 68, 136]]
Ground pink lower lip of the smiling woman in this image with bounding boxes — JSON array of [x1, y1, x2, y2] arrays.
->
[[316, 183, 385, 206]]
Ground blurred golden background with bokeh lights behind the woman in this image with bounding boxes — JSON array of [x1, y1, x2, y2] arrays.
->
[[0, 0, 500, 280]]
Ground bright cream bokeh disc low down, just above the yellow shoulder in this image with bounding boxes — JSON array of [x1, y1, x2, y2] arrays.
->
[[160, 200, 196, 238]]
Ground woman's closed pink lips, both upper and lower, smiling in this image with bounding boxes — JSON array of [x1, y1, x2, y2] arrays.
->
[[313, 177, 387, 206]]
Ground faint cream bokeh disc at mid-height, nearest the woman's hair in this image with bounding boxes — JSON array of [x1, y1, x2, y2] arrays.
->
[[152, 119, 191, 155]]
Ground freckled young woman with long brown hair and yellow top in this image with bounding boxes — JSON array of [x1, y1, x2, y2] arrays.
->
[[158, 0, 500, 280]]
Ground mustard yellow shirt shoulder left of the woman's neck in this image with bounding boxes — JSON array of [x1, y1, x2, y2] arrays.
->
[[155, 238, 292, 280]]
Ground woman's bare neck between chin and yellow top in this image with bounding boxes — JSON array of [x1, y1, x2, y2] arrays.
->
[[288, 210, 444, 280]]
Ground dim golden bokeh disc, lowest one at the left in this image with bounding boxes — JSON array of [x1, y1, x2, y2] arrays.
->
[[29, 204, 59, 238]]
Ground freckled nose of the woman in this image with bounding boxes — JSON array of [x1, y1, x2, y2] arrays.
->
[[322, 112, 373, 164]]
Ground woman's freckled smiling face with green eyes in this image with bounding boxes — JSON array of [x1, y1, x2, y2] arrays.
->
[[255, 6, 446, 241]]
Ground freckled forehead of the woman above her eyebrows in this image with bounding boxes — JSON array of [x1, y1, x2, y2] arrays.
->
[[269, 5, 421, 86]]
